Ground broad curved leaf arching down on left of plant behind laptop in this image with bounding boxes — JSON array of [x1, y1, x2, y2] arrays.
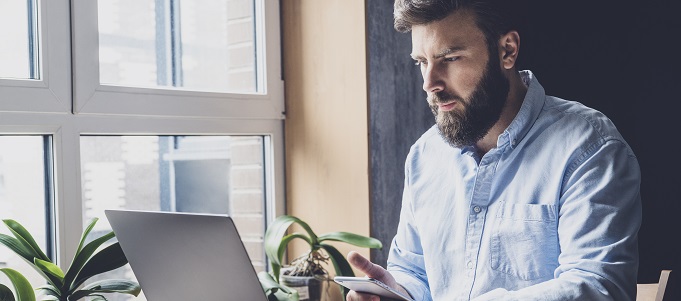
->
[[265, 215, 317, 280]]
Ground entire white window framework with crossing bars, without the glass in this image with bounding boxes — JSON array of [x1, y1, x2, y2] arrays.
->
[[0, 0, 285, 268]]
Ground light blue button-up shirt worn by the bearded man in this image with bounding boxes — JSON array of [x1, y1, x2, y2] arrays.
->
[[388, 71, 641, 301]]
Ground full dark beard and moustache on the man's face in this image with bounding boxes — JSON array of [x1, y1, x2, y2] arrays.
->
[[428, 56, 510, 148]]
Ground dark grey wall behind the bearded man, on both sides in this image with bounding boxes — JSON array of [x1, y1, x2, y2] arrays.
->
[[366, 0, 681, 300]]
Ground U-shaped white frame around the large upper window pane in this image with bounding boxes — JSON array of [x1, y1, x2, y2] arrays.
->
[[73, 0, 284, 119]]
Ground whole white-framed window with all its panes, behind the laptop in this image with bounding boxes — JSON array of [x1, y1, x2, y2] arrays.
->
[[0, 0, 283, 300]]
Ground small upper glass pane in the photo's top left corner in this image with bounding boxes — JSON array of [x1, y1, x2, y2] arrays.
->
[[0, 0, 38, 79]]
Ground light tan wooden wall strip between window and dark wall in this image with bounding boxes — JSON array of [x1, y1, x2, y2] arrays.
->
[[281, 0, 369, 288]]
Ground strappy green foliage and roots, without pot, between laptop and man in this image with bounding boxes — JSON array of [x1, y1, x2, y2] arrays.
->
[[265, 215, 383, 294]]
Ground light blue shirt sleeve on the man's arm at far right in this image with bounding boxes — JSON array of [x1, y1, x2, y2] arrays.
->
[[474, 140, 641, 301]]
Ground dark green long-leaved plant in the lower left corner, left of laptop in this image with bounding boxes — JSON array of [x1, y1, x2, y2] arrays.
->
[[0, 218, 141, 301]]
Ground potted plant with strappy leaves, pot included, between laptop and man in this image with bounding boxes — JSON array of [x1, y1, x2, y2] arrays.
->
[[261, 215, 383, 301]]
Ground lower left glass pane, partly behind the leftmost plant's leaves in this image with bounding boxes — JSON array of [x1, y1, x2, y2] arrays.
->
[[0, 136, 50, 287]]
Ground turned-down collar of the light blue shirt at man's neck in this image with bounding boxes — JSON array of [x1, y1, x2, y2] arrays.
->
[[497, 70, 546, 148]]
